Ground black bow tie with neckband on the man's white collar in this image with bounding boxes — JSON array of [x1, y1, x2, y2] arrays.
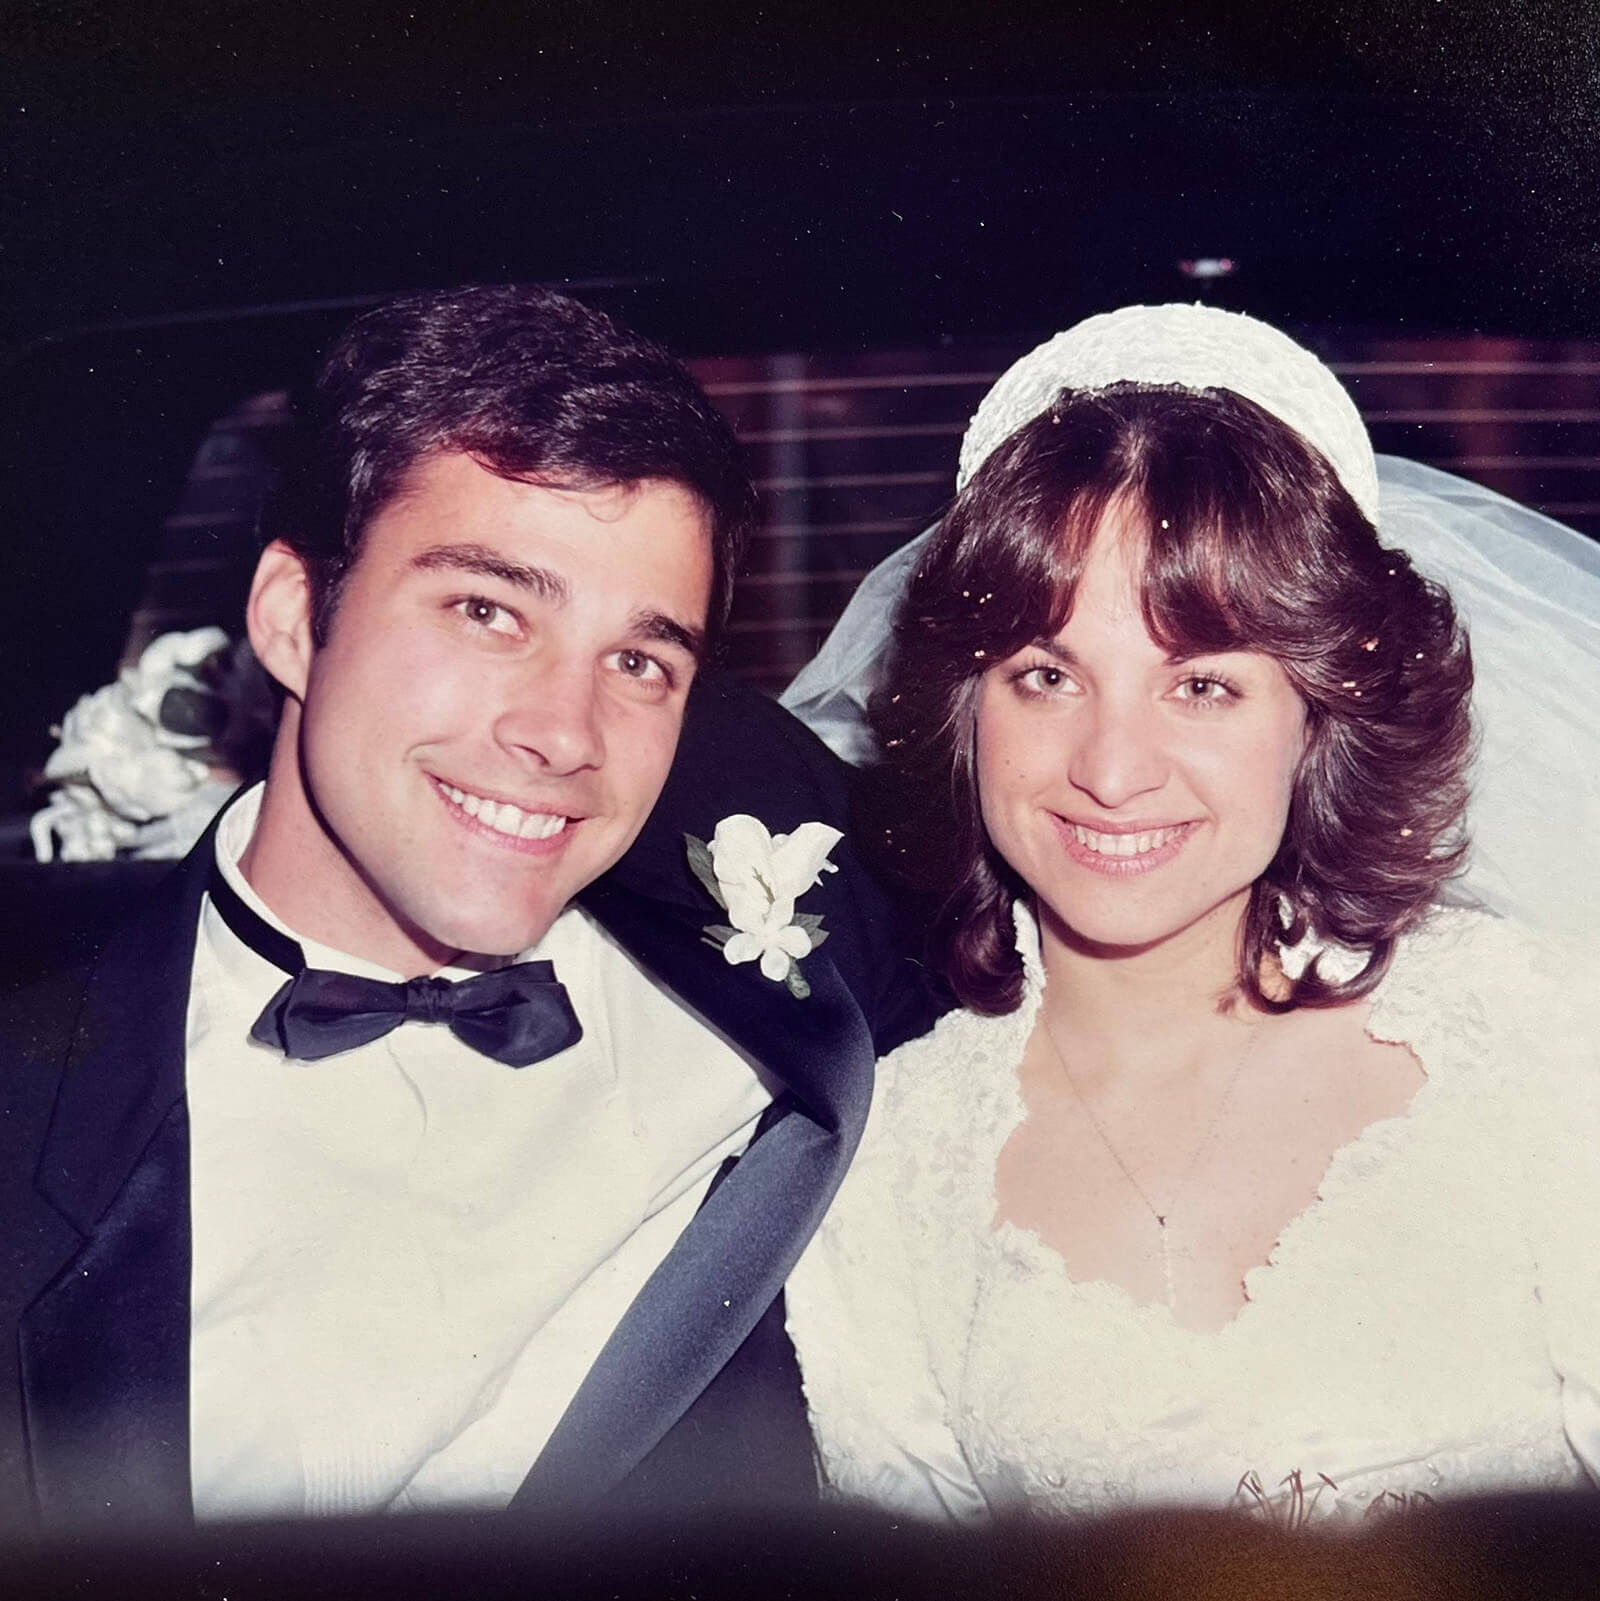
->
[[210, 873, 583, 1068]]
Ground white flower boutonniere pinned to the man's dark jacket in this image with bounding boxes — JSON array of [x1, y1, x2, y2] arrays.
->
[[684, 813, 844, 999]]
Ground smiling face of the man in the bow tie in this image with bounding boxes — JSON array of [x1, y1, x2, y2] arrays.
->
[[251, 453, 711, 972]]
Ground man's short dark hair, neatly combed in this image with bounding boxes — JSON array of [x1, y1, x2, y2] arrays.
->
[[261, 283, 758, 642]]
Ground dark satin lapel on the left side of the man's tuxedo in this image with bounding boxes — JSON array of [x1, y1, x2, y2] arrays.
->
[[19, 834, 211, 1526]]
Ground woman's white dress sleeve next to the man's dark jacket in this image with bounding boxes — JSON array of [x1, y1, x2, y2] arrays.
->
[[786, 1042, 987, 1521]]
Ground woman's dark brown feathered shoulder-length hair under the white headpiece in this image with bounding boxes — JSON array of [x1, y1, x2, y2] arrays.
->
[[868, 384, 1472, 1012]]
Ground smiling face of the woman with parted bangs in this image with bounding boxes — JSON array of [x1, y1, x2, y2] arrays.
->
[[977, 503, 1305, 959]]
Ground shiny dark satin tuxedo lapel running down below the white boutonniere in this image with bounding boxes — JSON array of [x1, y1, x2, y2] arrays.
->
[[511, 885, 873, 1510]]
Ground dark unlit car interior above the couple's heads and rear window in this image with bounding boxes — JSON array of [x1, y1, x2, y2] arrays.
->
[[0, 0, 1600, 812]]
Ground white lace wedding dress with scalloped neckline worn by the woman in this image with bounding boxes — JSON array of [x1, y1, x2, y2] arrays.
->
[[788, 909, 1600, 1519]]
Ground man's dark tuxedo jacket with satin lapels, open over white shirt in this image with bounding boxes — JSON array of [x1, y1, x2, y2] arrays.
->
[[0, 677, 934, 1527]]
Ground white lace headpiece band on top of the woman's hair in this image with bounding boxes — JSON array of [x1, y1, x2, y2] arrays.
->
[[956, 306, 1377, 524]]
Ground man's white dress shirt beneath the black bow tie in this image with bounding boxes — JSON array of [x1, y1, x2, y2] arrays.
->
[[187, 791, 772, 1518]]
